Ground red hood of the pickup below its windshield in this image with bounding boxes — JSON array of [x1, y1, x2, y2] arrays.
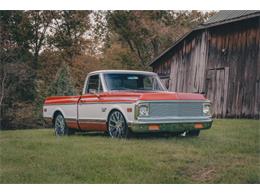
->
[[104, 91, 206, 101]]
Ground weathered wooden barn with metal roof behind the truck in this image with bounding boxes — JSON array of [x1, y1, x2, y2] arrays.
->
[[149, 10, 260, 119]]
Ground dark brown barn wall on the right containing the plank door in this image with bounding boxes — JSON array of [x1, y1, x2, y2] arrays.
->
[[206, 17, 260, 118]]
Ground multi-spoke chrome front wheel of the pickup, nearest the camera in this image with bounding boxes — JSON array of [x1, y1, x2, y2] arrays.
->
[[108, 111, 128, 138]]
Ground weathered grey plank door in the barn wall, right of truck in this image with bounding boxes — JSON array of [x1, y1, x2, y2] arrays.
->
[[206, 67, 229, 117]]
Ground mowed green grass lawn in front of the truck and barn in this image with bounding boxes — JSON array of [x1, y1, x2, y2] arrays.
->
[[0, 120, 260, 183]]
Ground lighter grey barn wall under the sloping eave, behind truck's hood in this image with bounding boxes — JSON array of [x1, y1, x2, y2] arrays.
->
[[154, 32, 207, 93]]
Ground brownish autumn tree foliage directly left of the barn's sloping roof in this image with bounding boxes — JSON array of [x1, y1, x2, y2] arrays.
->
[[107, 11, 213, 68]]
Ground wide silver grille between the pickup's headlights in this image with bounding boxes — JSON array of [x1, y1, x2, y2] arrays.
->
[[150, 102, 203, 117]]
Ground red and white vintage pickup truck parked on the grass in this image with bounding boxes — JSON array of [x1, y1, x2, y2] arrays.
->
[[43, 70, 212, 138]]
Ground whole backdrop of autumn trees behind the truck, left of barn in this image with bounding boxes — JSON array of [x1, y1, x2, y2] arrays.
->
[[0, 11, 214, 129]]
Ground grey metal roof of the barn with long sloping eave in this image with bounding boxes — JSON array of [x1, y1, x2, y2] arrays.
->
[[148, 10, 260, 66]]
